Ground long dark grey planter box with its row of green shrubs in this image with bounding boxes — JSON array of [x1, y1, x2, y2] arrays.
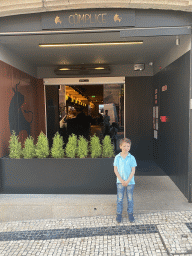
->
[[1, 132, 116, 194]]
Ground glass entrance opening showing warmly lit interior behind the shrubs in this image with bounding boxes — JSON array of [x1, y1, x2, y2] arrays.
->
[[45, 78, 125, 151]]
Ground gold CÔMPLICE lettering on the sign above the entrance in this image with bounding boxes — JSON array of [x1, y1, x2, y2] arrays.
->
[[69, 13, 107, 25]]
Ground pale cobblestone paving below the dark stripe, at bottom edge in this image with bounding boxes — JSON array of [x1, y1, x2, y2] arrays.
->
[[0, 233, 167, 256]]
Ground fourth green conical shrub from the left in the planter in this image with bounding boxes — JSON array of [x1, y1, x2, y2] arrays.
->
[[51, 132, 64, 158]]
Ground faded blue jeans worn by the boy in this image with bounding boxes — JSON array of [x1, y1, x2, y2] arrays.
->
[[117, 183, 135, 215]]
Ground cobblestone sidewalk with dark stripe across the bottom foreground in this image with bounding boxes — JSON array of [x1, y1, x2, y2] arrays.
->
[[0, 211, 192, 256]]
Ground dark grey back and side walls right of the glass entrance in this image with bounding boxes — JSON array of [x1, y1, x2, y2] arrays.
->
[[126, 52, 191, 199]]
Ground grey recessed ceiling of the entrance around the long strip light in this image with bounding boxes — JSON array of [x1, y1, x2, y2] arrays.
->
[[0, 32, 185, 67]]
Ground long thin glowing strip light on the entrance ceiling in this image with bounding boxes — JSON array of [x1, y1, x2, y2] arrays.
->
[[39, 41, 143, 48]]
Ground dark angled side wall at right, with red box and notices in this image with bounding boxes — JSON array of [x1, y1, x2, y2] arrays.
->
[[153, 52, 190, 198]]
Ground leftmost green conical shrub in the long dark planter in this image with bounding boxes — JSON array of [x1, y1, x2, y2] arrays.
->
[[9, 131, 22, 159]]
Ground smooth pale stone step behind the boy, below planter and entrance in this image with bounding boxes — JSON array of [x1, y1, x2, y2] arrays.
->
[[0, 176, 192, 222]]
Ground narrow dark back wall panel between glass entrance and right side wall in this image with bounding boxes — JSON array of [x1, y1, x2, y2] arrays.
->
[[125, 77, 153, 160]]
